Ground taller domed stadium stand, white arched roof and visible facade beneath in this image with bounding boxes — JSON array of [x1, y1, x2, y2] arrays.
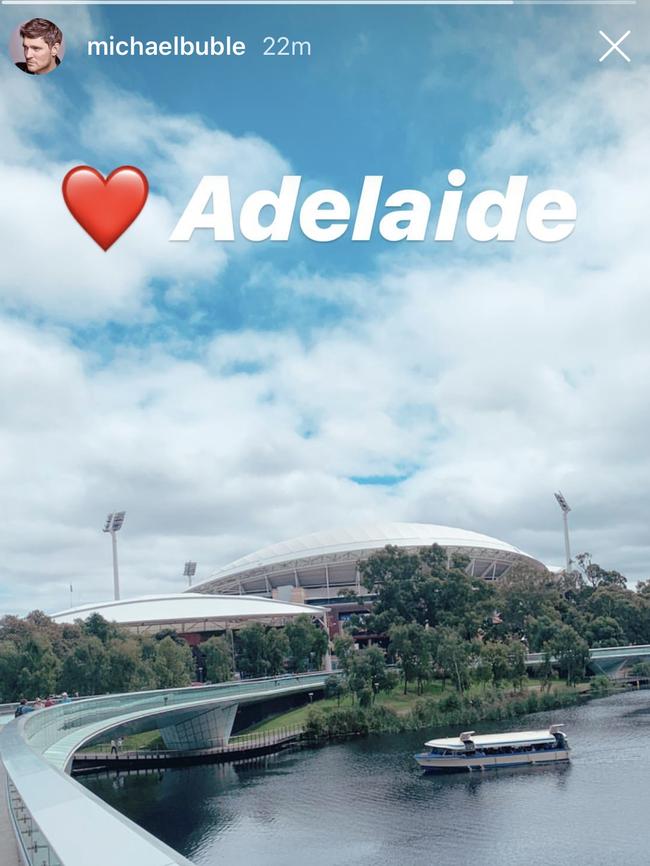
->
[[191, 523, 545, 632]]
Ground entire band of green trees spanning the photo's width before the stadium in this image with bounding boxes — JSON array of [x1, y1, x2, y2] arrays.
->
[[0, 545, 650, 705]]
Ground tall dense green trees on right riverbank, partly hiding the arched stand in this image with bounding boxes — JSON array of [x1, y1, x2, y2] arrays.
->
[[332, 545, 650, 692]]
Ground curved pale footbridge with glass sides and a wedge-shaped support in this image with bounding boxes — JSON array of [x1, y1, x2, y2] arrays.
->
[[0, 671, 331, 866]]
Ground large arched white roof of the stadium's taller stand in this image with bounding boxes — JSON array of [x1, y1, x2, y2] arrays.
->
[[192, 523, 542, 592]]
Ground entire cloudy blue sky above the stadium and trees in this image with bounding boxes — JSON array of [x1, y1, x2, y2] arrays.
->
[[0, 7, 650, 611]]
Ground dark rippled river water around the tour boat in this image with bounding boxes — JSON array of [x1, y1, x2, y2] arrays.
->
[[79, 691, 650, 866]]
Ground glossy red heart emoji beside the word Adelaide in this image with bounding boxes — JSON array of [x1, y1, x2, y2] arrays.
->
[[62, 165, 149, 251]]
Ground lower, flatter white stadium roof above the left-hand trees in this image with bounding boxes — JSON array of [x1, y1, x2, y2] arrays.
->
[[52, 592, 325, 632]]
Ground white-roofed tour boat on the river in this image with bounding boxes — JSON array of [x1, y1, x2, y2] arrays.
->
[[415, 725, 570, 773]]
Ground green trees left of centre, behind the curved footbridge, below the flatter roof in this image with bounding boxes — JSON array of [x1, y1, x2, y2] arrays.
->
[[0, 611, 328, 702]]
